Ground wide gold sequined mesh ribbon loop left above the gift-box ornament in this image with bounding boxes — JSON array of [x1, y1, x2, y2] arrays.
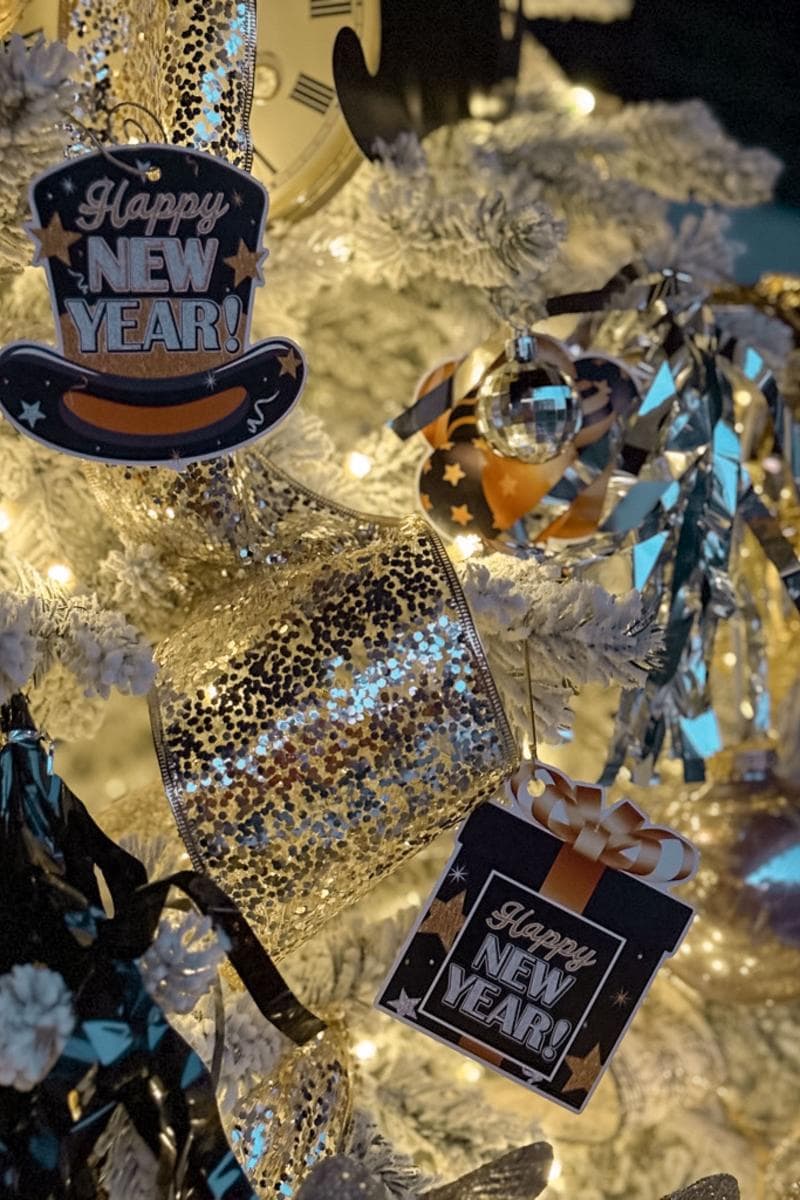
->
[[152, 518, 516, 954]]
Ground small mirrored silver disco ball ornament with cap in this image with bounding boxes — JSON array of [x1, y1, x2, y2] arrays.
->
[[476, 334, 583, 463]]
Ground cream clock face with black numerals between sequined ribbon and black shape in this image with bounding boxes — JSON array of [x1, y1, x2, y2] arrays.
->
[[251, 0, 380, 220]]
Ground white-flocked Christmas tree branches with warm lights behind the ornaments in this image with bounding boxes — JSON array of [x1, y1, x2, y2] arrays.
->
[[0, 0, 798, 1200]]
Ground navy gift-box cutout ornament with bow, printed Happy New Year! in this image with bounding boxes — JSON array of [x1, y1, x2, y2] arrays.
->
[[377, 763, 697, 1112]]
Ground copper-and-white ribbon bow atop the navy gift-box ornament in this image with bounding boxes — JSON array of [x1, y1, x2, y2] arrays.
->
[[506, 762, 698, 887]]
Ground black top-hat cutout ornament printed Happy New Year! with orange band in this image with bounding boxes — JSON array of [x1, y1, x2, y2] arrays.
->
[[0, 145, 306, 466]]
